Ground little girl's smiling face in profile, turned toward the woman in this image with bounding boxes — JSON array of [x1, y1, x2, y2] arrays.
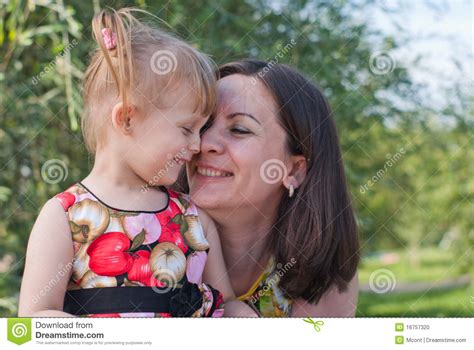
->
[[125, 84, 208, 186]]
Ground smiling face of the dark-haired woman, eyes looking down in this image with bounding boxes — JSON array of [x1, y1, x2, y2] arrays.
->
[[187, 74, 289, 213]]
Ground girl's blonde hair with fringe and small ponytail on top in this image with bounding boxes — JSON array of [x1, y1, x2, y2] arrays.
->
[[81, 8, 217, 153]]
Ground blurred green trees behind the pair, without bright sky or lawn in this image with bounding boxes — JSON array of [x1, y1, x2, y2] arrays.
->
[[0, 0, 474, 315]]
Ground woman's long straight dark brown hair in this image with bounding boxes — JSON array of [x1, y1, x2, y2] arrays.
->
[[219, 60, 359, 304]]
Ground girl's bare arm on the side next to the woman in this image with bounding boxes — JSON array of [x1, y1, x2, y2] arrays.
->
[[198, 208, 257, 317]]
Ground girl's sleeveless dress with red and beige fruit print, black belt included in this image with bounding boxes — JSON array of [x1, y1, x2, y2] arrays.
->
[[56, 182, 224, 317]]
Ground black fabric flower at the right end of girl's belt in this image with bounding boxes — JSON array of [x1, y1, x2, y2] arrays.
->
[[170, 282, 202, 317]]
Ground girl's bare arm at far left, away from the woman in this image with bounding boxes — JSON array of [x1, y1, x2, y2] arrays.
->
[[18, 198, 74, 317]]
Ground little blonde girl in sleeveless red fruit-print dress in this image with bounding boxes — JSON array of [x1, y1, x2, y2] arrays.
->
[[19, 9, 254, 317]]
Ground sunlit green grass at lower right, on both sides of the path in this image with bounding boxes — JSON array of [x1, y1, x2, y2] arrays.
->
[[357, 248, 474, 317]]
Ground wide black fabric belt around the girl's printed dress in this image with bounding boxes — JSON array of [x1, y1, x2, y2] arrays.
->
[[64, 286, 180, 315]]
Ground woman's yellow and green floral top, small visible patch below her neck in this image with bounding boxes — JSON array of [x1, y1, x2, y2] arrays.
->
[[238, 259, 293, 317]]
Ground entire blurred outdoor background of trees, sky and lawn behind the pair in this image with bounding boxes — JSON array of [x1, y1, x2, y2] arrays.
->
[[0, 0, 474, 317]]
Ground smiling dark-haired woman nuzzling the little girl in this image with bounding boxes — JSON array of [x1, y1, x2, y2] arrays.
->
[[181, 60, 359, 317]]
